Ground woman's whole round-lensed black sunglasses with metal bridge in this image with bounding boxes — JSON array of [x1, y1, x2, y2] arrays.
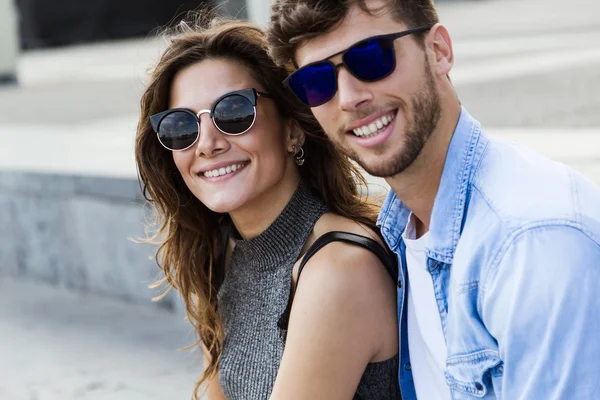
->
[[150, 88, 271, 151]]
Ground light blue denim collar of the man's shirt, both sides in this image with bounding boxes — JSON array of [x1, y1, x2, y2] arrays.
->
[[377, 108, 481, 264]]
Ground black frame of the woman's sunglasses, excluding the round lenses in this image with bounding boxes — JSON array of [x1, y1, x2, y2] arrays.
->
[[150, 88, 272, 151]]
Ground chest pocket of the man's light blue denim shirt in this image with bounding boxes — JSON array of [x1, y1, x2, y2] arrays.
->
[[446, 350, 502, 400]]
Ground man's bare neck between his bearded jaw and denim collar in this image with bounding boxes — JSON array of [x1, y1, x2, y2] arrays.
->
[[386, 102, 460, 238]]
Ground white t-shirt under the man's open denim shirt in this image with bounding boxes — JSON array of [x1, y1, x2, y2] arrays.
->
[[403, 215, 450, 400]]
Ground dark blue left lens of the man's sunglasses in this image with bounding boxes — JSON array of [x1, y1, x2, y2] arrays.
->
[[288, 62, 337, 107]]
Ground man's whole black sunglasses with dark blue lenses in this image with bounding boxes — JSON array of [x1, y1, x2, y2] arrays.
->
[[283, 26, 431, 107]]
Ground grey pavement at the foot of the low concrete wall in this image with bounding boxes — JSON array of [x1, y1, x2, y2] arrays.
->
[[0, 276, 202, 400]]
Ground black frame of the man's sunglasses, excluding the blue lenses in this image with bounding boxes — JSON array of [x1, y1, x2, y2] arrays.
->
[[283, 26, 431, 108]]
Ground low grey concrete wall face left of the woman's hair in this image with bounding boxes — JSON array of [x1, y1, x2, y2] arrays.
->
[[0, 171, 179, 308]]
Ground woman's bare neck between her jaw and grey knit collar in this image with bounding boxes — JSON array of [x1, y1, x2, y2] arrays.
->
[[229, 173, 300, 240]]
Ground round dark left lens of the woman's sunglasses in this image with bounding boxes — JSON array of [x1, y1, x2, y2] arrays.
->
[[158, 111, 198, 150]]
